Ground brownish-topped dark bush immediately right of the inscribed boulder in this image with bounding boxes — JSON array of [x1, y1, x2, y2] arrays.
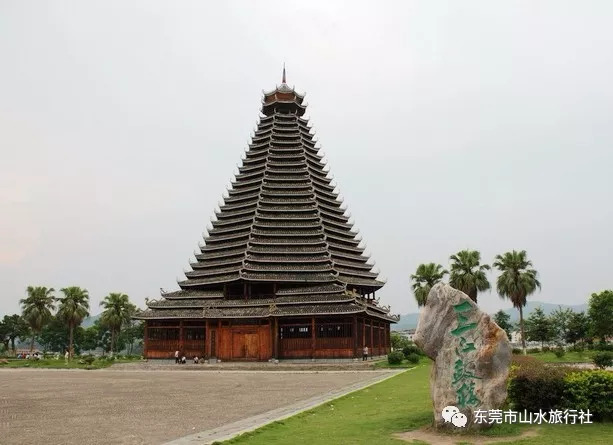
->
[[508, 356, 572, 412]]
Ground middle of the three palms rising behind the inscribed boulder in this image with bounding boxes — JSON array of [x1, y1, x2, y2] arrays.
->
[[449, 250, 490, 303]]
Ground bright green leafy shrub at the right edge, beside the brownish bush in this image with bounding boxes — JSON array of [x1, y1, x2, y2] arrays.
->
[[563, 371, 613, 420]]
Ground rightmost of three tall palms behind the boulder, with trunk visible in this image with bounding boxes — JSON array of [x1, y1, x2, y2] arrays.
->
[[494, 250, 541, 354]]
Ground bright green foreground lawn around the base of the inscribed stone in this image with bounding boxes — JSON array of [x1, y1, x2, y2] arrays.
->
[[223, 362, 613, 445]]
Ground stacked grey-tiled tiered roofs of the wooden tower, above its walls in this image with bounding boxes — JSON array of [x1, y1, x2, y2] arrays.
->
[[140, 73, 393, 320]]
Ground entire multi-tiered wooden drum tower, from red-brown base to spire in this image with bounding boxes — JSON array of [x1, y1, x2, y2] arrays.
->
[[135, 71, 399, 360]]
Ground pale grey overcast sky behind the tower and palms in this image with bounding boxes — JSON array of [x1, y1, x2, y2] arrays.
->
[[0, 0, 613, 314]]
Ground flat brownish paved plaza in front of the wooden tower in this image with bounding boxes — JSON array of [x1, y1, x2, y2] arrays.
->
[[0, 365, 390, 445]]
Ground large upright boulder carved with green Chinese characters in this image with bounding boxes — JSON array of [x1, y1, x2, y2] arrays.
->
[[414, 283, 511, 429]]
